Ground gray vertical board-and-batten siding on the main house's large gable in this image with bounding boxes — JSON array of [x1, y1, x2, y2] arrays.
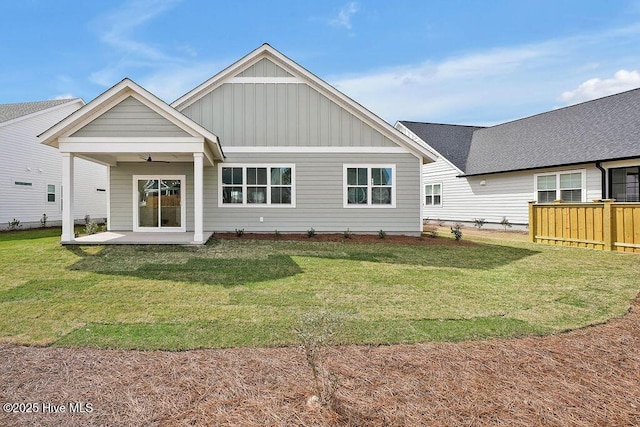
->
[[181, 83, 397, 149]]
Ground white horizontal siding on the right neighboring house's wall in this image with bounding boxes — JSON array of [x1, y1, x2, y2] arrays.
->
[[422, 159, 601, 225]]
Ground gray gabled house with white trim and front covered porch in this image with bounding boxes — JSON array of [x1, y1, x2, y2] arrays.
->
[[40, 44, 435, 244]]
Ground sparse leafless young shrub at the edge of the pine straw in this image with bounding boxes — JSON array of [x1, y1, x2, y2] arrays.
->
[[293, 311, 339, 407]]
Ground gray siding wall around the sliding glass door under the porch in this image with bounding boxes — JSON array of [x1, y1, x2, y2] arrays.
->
[[109, 163, 196, 231]]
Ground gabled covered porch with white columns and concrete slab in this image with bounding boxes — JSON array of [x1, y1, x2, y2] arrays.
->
[[40, 79, 224, 245]]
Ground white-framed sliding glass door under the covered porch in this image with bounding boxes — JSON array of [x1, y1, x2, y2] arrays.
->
[[136, 177, 183, 230]]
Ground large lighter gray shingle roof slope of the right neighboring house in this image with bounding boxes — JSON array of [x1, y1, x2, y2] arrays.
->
[[463, 89, 640, 175]]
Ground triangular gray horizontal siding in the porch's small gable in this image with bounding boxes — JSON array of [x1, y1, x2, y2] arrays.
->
[[72, 96, 190, 137]]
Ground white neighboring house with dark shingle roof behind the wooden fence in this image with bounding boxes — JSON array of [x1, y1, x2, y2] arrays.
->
[[396, 89, 640, 227]]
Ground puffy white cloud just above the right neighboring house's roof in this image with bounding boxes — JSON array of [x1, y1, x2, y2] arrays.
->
[[559, 70, 640, 104]]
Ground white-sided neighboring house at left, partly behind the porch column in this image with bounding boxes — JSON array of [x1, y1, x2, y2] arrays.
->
[[0, 99, 107, 229]]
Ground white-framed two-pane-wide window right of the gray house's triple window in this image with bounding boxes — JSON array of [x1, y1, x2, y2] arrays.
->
[[344, 165, 396, 207]]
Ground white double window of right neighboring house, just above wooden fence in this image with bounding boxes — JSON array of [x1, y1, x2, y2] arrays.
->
[[535, 171, 586, 203]]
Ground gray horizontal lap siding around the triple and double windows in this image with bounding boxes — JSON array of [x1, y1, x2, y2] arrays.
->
[[204, 153, 421, 234]]
